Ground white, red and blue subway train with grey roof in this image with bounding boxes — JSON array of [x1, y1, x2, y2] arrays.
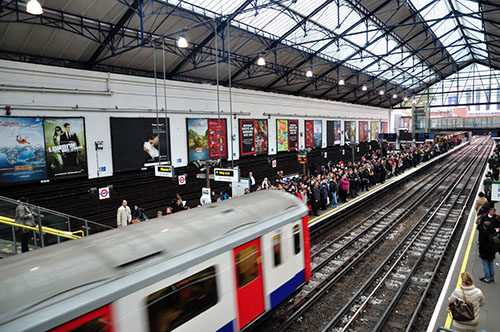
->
[[0, 190, 311, 332]]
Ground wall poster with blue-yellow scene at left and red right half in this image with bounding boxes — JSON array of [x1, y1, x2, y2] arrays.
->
[[187, 119, 227, 162]]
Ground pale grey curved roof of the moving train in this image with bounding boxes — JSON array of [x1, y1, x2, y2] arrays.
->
[[0, 190, 307, 327]]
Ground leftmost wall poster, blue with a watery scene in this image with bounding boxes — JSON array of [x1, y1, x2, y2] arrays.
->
[[0, 117, 47, 184]]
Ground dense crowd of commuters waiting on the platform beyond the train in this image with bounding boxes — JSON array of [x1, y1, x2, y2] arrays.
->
[[244, 139, 460, 215]]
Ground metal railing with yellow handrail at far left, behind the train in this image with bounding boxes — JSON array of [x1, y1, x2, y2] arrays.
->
[[0, 196, 112, 255]]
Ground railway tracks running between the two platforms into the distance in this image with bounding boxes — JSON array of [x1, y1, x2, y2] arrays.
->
[[265, 137, 488, 331]]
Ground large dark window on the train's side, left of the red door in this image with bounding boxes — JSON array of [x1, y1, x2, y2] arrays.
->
[[146, 266, 217, 332]]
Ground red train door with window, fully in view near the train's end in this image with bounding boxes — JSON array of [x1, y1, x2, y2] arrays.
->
[[234, 239, 265, 329]]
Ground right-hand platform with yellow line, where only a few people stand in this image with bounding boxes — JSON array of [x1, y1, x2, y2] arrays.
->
[[427, 147, 500, 332]]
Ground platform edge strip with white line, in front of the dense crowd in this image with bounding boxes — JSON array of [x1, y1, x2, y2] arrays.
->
[[309, 141, 470, 228]]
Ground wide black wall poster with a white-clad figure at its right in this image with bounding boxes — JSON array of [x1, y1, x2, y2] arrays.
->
[[110, 118, 170, 172]]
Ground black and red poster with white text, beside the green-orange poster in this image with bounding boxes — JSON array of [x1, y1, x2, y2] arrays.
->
[[240, 119, 267, 156]]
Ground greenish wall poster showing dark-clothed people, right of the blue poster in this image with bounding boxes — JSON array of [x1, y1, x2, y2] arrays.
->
[[44, 118, 87, 177]]
